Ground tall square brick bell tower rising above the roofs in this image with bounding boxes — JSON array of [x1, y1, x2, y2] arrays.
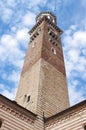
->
[[16, 12, 69, 117]]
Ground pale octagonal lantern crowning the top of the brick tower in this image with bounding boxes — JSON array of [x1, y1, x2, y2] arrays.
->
[[36, 11, 56, 24]]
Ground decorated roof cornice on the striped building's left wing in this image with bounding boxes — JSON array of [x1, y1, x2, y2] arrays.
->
[[0, 94, 37, 123]]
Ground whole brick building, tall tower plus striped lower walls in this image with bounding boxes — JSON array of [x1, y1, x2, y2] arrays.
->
[[0, 12, 86, 130]]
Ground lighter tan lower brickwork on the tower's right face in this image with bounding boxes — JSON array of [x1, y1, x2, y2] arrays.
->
[[37, 59, 69, 117]]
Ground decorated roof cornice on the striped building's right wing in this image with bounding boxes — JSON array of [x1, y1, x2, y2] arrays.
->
[[45, 100, 86, 127]]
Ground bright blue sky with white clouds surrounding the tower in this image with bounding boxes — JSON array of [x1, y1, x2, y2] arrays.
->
[[0, 0, 86, 105]]
